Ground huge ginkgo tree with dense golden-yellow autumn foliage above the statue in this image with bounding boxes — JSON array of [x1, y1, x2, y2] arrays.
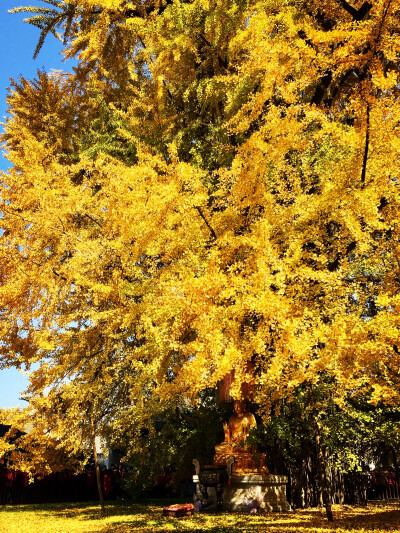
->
[[0, 0, 400, 515]]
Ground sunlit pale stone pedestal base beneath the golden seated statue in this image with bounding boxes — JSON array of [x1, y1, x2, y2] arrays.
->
[[222, 475, 290, 512]]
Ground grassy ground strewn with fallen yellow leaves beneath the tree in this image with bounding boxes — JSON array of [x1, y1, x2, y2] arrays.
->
[[0, 501, 400, 533]]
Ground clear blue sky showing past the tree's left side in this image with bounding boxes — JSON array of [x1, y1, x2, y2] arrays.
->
[[0, 0, 75, 409]]
